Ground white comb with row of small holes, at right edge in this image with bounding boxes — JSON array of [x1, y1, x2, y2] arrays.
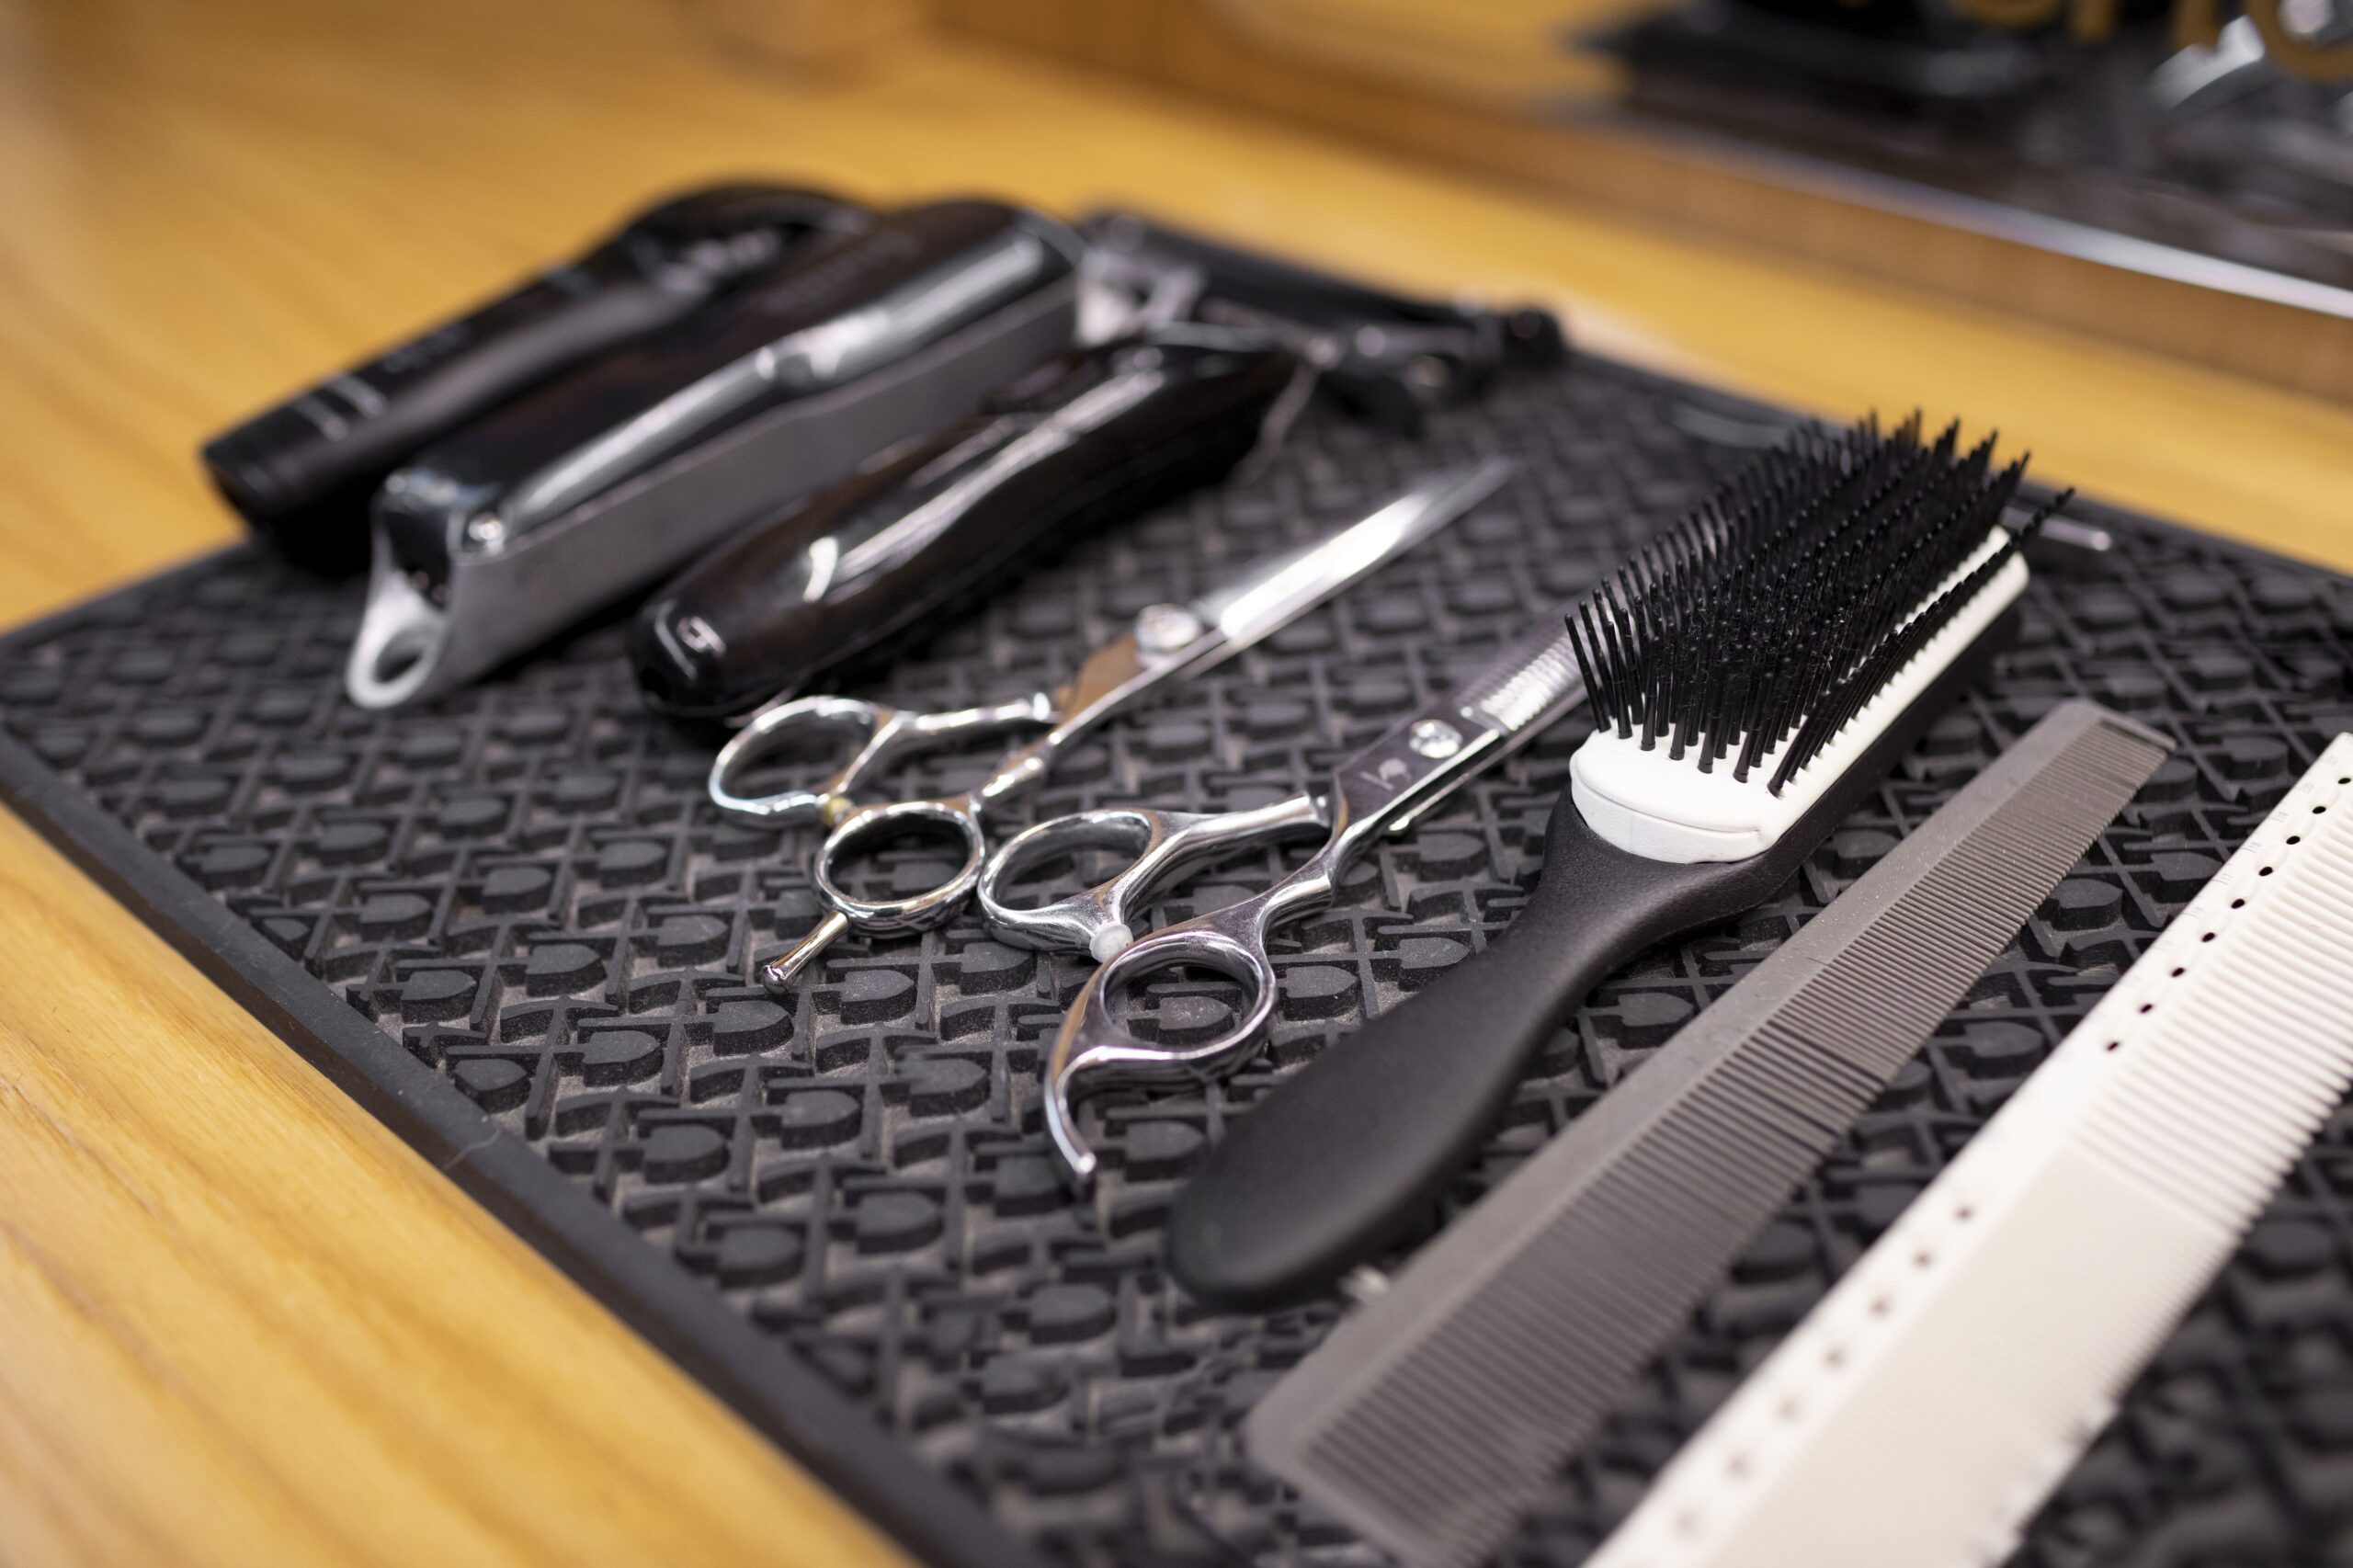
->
[[1591, 734, 2353, 1568]]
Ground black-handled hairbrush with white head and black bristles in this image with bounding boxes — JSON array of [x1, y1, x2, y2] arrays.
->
[[1167, 415, 2066, 1309]]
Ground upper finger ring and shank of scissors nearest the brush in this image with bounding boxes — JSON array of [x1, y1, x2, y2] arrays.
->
[[979, 796, 1324, 963]]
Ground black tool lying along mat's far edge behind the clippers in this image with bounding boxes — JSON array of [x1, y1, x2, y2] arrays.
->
[[1085, 212, 1567, 431]]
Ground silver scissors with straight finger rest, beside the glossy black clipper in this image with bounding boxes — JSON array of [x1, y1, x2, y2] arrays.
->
[[710, 460, 1511, 989]]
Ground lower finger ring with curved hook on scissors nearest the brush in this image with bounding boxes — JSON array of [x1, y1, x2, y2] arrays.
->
[[1045, 900, 1276, 1189]]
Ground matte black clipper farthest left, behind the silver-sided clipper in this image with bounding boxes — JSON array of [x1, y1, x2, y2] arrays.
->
[[202, 184, 873, 570]]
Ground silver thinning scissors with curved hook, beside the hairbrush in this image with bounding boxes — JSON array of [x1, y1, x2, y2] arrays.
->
[[979, 631, 1586, 1189]]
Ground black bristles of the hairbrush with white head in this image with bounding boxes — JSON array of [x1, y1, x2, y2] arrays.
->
[[1570, 415, 2050, 793]]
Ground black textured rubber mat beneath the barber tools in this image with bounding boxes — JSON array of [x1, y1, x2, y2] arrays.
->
[[0, 360, 2353, 1568]]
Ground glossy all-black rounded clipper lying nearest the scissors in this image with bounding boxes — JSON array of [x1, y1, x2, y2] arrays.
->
[[631, 324, 1308, 718]]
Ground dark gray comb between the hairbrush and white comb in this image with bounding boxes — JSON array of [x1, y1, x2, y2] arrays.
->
[[1245, 701, 2172, 1568]]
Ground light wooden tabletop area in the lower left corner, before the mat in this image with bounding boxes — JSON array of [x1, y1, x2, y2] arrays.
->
[[0, 817, 899, 1563]]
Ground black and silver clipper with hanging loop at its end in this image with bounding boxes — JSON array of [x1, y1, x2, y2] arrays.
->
[[346, 200, 1085, 709]]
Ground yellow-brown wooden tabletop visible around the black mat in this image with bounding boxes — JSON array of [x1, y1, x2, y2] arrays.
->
[[0, 0, 2353, 1563]]
